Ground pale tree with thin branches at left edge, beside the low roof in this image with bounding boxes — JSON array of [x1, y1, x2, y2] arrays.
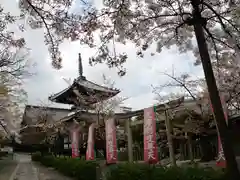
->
[[0, 46, 31, 134]]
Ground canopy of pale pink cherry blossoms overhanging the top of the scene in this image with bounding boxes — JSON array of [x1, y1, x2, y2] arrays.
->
[[5, 0, 234, 75]]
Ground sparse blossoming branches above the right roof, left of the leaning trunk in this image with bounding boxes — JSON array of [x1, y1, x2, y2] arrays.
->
[[152, 70, 212, 120]]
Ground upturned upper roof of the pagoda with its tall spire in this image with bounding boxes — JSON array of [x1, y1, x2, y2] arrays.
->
[[49, 54, 120, 106]]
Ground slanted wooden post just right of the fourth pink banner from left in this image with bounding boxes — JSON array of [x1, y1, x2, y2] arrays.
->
[[165, 110, 177, 166]]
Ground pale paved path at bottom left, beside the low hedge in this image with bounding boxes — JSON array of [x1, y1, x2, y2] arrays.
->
[[0, 154, 71, 180]]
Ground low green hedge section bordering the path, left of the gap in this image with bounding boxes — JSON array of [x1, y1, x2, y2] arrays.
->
[[32, 153, 97, 180]]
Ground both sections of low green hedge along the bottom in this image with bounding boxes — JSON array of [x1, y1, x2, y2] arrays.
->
[[32, 153, 225, 180]]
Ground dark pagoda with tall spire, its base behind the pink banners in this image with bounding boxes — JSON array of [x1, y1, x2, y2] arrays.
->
[[49, 53, 120, 156]]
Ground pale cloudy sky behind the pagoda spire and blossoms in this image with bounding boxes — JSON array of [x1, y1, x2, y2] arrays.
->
[[1, 0, 202, 109]]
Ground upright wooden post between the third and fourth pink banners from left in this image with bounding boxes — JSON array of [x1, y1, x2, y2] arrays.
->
[[125, 119, 133, 162]]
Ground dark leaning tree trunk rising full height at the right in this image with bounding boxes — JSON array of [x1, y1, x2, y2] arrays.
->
[[191, 0, 240, 177]]
